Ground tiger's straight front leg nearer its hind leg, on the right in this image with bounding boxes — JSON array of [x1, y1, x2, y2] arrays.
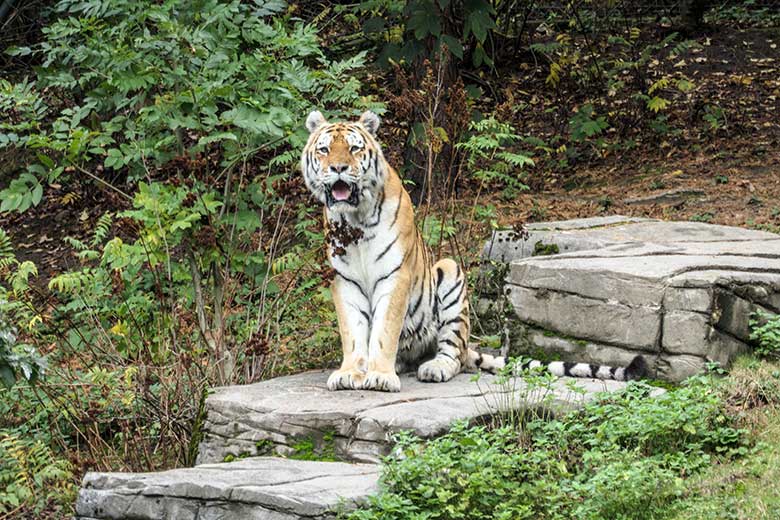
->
[[363, 273, 410, 392]]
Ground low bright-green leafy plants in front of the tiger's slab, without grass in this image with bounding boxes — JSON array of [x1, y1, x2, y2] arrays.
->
[[350, 378, 747, 520]]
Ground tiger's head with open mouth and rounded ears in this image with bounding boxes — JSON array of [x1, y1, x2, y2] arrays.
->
[[301, 111, 386, 213]]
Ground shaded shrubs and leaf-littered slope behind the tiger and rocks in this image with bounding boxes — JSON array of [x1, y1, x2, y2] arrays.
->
[[0, 0, 780, 517]]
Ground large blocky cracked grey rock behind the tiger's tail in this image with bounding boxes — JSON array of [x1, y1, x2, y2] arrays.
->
[[483, 216, 780, 381]]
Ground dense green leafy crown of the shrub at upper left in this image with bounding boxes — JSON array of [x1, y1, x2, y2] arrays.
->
[[0, 0, 374, 211]]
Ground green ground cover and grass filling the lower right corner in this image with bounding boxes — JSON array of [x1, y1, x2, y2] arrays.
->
[[348, 359, 780, 520]]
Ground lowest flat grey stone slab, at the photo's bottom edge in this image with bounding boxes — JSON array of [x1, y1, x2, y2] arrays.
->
[[75, 457, 379, 520]]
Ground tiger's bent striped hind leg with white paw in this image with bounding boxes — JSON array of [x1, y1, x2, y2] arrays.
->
[[417, 258, 470, 383]]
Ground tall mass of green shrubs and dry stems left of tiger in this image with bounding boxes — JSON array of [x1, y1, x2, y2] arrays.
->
[[0, 0, 376, 507]]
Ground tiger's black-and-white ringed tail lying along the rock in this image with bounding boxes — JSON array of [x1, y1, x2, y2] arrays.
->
[[466, 349, 650, 381]]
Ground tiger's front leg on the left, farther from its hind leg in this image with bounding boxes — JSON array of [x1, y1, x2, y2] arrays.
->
[[328, 276, 371, 390]]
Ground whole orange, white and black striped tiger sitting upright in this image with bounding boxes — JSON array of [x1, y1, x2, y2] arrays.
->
[[301, 111, 643, 392]]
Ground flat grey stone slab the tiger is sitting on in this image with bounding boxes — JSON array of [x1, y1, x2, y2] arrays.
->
[[198, 370, 623, 463]]
